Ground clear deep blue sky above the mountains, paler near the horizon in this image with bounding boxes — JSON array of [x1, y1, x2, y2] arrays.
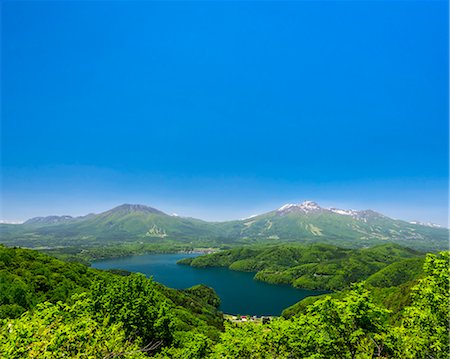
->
[[1, 1, 449, 225]]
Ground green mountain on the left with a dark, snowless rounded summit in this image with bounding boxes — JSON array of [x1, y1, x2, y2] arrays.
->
[[0, 204, 220, 248]]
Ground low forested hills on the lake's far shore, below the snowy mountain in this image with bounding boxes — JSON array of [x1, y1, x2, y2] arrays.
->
[[178, 244, 423, 290]]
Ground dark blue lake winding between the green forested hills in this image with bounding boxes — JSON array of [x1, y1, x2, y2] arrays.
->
[[92, 253, 326, 316]]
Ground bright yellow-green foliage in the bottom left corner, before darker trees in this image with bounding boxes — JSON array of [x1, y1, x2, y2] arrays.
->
[[0, 298, 147, 359]]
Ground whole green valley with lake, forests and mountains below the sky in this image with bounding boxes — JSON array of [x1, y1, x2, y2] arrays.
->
[[0, 201, 449, 359]]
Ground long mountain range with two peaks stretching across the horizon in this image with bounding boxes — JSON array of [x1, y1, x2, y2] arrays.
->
[[0, 201, 449, 250]]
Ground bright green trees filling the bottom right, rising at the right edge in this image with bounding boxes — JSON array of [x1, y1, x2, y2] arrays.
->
[[212, 252, 450, 359]]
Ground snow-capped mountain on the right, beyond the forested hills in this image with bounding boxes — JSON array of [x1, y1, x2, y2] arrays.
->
[[213, 201, 449, 249]]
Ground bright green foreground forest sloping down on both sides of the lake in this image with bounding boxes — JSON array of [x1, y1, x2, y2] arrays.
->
[[0, 247, 449, 358]]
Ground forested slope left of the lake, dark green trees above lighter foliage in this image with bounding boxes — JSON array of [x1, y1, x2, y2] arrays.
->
[[0, 246, 223, 358]]
